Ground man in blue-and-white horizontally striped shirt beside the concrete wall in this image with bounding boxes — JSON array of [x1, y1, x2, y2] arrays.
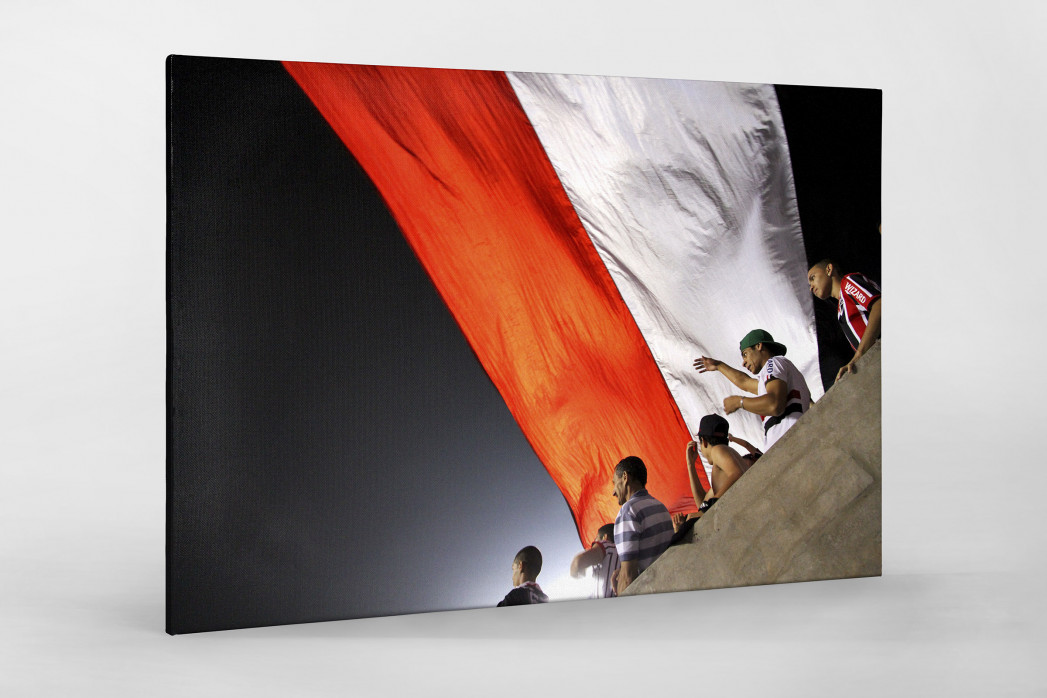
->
[[611, 455, 672, 595]]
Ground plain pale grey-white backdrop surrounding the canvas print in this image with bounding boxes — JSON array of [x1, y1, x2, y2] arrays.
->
[[0, 0, 1047, 696]]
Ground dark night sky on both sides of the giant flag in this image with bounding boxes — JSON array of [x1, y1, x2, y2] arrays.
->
[[168, 57, 881, 632]]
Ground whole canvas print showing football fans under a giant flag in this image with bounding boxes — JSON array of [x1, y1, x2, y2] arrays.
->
[[166, 55, 883, 634]]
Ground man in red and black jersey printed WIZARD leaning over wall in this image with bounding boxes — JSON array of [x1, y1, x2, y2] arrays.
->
[[807, 260, 884, 381]]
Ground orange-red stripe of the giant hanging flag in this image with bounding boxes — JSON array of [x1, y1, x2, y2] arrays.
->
[[284, 63, 708, 544]]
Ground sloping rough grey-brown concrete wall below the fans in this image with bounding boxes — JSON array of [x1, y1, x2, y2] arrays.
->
[[623, 342, 882, 595]]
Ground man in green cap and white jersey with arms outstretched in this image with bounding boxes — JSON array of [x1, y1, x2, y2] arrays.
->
[[694, 330, 810, 451]]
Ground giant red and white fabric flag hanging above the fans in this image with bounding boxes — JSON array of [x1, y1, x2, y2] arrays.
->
[[284, 63, 821, 543]]
